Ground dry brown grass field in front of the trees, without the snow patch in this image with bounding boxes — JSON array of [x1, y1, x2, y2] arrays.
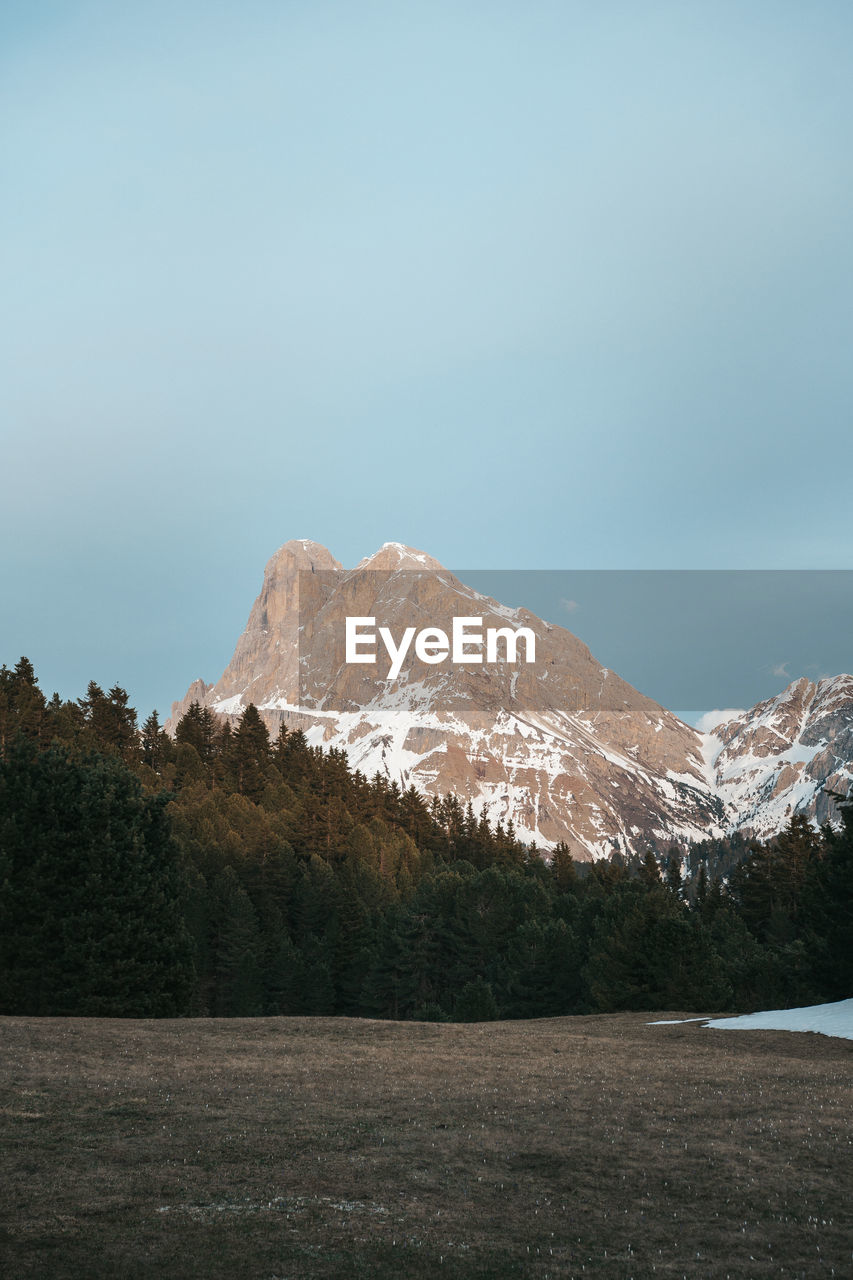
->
[[0, 1014, 853, 1280]]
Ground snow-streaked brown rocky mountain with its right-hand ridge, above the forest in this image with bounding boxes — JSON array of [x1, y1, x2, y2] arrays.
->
[[167, 540, 853, 858]]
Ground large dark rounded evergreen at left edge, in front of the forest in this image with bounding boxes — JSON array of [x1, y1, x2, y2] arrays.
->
[[0, 739, 193, 1016]]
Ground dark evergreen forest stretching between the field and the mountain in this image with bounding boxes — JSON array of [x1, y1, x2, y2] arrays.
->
[[0, 659, 853, 1020]]
